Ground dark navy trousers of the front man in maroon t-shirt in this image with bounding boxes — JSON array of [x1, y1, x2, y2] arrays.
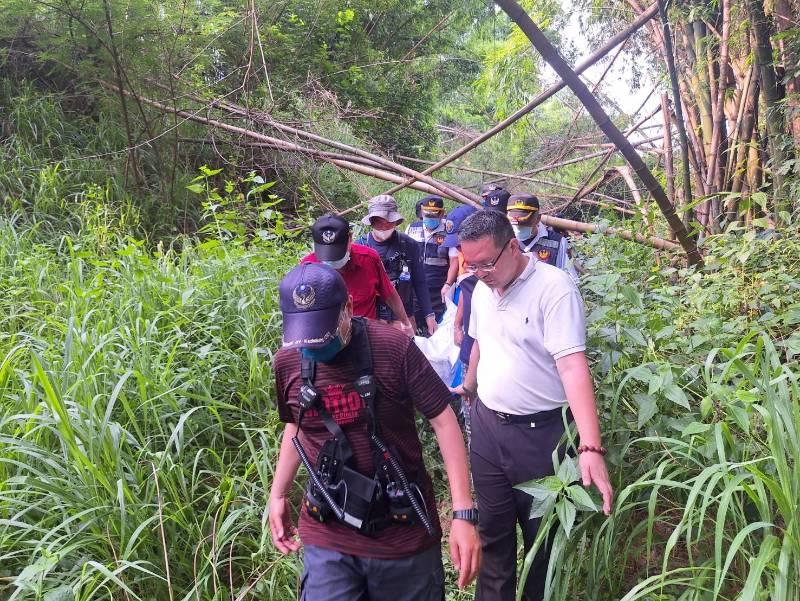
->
[[300, 534, 444, 601]]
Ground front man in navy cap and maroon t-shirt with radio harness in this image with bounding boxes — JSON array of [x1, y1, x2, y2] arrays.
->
[[268, 263, 480, 601]]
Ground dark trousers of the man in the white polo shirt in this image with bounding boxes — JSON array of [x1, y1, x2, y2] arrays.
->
[[470, 400, 564, 601]]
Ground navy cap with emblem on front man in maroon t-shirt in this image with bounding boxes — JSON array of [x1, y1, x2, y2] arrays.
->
[[278, 263, 348, 348]]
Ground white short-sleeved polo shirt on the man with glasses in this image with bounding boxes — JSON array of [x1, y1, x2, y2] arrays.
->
[[469, 257, 586, 415]]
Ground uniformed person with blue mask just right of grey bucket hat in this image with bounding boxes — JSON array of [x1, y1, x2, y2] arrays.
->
[[406, 194, 450, 323]]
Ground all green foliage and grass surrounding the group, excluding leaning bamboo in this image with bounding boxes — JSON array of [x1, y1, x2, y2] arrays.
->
[[0, 0, 800, 601]]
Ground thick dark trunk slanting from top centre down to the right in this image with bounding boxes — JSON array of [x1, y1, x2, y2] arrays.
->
[[495, 0, 703, 265]]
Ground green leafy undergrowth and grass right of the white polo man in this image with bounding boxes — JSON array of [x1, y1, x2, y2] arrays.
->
[[528, 231, 800, 601]]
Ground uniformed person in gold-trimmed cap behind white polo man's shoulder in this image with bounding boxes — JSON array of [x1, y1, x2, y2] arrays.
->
[[507, 194, 578, 281]]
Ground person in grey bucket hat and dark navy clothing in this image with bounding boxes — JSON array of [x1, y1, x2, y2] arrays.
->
[[358, 194, 437, 334]]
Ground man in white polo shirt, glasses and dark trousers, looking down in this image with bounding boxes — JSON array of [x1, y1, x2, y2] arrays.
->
[[458, 211, 613, 601]]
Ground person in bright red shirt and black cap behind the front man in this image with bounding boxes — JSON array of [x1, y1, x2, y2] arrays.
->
[[300, 215, 414, 336]]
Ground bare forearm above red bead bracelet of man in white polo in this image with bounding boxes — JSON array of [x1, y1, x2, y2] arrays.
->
[[556, 352, 600, 446]]
